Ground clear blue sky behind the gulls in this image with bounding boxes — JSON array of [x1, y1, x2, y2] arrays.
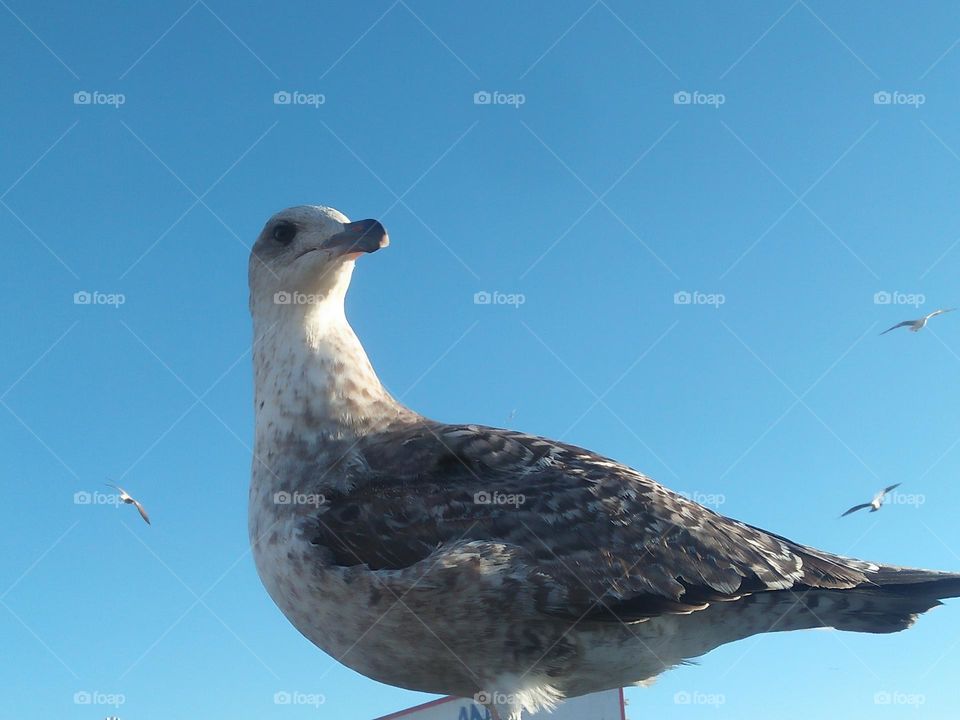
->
[[0, 0, 960, 720]]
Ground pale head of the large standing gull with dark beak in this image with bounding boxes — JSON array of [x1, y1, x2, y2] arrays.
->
[[249, 205, 389, 310]]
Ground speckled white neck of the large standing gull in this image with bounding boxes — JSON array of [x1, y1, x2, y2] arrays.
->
[[254, 296, 412, 439]]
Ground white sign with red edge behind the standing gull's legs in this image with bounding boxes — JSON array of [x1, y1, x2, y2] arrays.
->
[[376, 689, 627, 720]]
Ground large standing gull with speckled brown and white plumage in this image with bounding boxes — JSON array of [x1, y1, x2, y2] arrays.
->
[[249, 206, 960, 720]]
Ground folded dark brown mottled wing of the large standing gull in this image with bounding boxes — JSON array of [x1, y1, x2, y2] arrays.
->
[[312, 421, 875, 621]]
